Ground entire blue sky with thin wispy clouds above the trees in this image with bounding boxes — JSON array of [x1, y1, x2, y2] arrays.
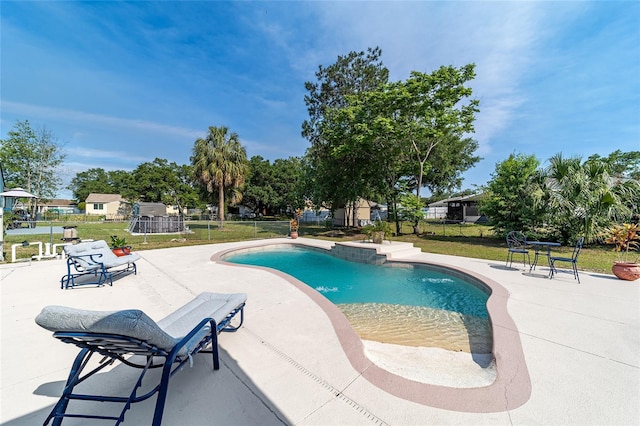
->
[[0, 0, 640, 198]]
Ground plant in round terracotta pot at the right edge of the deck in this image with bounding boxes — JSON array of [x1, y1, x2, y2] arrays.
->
[[606, 223, 640, 281]]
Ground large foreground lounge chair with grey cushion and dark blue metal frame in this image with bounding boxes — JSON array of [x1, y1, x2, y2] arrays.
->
[[36, 293, 247, 426]]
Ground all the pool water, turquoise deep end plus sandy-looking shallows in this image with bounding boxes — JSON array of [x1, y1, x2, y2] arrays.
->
[[224, 246, 492, 354]]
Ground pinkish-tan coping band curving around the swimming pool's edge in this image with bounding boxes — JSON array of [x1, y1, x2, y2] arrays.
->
[[211, 240, 532, 413]]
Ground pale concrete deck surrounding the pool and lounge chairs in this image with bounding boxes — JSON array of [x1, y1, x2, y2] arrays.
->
[[0, 239, 640, 425]]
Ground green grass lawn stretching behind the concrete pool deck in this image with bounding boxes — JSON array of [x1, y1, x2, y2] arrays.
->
[[4, 221, 616, 274]]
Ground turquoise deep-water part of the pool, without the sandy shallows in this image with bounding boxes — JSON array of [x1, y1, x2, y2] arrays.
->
[[225, 247, 488, 318]]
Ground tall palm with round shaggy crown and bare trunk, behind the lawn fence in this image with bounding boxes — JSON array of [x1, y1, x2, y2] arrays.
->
[[191, 126, 249, 221]]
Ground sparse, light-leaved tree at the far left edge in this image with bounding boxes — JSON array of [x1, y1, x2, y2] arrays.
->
[[0, 120, 66, 209]]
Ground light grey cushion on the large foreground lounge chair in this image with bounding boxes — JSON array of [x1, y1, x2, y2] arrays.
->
[[36, 293, 247, 357]]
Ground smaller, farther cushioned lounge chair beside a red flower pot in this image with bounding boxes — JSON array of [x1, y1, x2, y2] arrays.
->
[[60, 240, 140, 288]]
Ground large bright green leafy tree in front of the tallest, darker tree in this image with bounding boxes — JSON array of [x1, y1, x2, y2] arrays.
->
[[308, 59, 479, 233]]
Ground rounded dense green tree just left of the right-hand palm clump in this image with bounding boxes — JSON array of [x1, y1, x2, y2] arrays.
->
[[480, 154, 542, 236]]
